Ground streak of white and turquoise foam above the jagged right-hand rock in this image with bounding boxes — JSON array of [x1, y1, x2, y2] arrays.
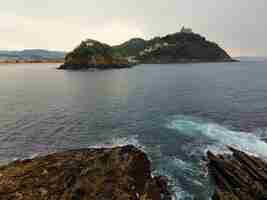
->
[[167, 116, 267, 158]]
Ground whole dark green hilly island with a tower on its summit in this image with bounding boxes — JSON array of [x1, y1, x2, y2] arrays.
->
[[59, 27, 235, 70]]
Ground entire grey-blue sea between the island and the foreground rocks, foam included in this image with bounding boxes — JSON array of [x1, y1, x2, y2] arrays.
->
[[0, 61, 267, 200]]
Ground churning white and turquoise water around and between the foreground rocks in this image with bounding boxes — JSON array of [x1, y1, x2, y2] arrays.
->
[[85, 115, 267, 200]]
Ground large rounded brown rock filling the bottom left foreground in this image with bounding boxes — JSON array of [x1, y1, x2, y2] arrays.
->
[[0, 146, 171, 200]]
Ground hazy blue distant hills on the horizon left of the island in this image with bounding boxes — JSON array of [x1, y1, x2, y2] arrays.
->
[[0, 49, 65, 60]]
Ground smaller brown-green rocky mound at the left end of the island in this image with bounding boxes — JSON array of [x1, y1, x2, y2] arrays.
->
[[59, 39, 131, 70]]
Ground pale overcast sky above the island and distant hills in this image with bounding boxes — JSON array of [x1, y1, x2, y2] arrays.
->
[[0, 0, 267, 56]]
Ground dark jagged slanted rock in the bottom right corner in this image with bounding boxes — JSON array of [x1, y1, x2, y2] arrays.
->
[[208, 148, 267, 200]]
